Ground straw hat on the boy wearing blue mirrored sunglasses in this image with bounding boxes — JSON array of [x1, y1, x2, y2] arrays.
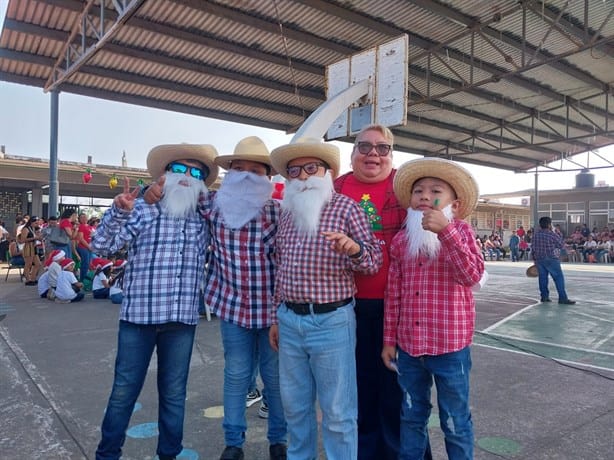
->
[[147, 144, 219, 186]]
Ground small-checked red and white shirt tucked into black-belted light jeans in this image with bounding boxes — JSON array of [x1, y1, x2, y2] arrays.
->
[[274, 193, 382, 323]]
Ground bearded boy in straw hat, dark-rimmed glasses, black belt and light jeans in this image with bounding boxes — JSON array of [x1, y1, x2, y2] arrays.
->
[[270, 139, 382, 460]]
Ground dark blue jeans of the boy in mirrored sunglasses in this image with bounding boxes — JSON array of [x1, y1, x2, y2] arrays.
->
[[96, 321, 196, 460]]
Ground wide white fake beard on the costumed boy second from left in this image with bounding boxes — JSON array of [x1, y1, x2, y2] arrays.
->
[[213, 169, 273, 230]]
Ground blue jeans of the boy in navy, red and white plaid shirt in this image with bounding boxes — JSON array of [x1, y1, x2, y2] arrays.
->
[[220, 321, 287, 447]]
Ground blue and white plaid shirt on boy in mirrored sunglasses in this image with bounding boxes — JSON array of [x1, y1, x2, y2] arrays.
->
[[92, 199, 209, 324]]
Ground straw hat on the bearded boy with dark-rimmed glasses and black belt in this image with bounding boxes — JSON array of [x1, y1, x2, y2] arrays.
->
[[271, 137, 340, 179]]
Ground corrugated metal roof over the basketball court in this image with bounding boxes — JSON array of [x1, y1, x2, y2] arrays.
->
[[0, 0, 614, 171]]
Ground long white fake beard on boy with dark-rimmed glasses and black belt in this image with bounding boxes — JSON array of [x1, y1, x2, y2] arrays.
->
[[281, 171, 334, 237]]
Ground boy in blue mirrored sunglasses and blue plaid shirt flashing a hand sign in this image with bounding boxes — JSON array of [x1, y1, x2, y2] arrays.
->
[[92, 144, 218, 460]]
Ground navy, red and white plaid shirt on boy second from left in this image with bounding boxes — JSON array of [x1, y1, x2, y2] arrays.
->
[[201, 200, 280, 328]]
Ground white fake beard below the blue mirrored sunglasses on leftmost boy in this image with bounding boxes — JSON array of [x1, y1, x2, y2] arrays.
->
[[160, 171, 207, 219]]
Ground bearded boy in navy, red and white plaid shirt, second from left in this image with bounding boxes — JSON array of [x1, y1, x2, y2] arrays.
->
[[205, 136, 286, 460]]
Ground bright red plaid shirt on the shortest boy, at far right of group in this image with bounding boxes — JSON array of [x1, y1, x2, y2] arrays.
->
[[384, 219, 484, 356]]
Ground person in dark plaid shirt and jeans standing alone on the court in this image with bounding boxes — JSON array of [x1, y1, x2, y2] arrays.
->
[[531, 216, 576, 305]]
